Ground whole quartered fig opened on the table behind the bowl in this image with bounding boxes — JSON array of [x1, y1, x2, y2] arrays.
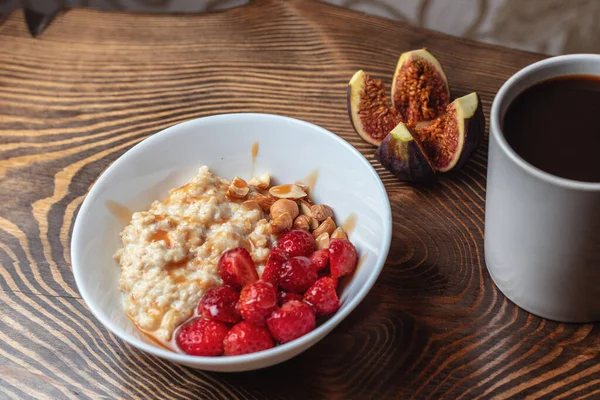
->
[[348, 49, 485, 182]]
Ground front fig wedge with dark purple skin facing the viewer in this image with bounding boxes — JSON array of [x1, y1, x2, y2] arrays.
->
[[375, 122, 435, 182]]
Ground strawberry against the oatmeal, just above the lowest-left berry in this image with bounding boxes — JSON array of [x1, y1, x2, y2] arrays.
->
[[198, 285, 242, 324]]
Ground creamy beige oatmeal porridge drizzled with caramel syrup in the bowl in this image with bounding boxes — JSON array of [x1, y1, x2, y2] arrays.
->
[[115, 166, 274, 341]]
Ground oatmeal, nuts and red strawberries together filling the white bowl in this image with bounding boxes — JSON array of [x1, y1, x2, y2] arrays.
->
[[115, 166, 358, 356]]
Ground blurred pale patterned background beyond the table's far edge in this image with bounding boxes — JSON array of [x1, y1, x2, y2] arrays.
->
[[0, 0, 600, 55]]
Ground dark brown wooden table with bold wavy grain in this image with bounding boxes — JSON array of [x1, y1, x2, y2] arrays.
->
[[0, 0, 600, 399]]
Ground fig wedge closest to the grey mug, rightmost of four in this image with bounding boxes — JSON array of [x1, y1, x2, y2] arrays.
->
[[413, 92, 485, 172]]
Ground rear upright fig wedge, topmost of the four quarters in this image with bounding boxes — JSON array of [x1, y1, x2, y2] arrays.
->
[[392, 49, 450, 125]]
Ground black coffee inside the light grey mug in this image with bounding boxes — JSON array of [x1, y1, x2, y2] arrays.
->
[[502, 75, 600, 182]]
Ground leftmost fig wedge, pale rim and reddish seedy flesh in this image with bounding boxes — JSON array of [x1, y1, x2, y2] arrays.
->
[[348, 70, 400, 146]]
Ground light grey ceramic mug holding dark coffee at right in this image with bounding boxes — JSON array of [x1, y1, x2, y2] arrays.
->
[[485, 54, 600, 322]]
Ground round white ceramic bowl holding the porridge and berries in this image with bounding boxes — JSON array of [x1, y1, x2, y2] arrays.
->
[[71, 114, 392, 372]]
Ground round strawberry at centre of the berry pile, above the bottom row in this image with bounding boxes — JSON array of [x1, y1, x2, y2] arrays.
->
[[237, 281, 277, 326]]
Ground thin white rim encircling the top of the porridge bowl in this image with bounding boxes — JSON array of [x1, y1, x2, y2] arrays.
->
[[70, 113, 392, 367]]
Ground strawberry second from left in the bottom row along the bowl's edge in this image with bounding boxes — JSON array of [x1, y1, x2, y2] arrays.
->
[[223, 321, 275, 356]]
